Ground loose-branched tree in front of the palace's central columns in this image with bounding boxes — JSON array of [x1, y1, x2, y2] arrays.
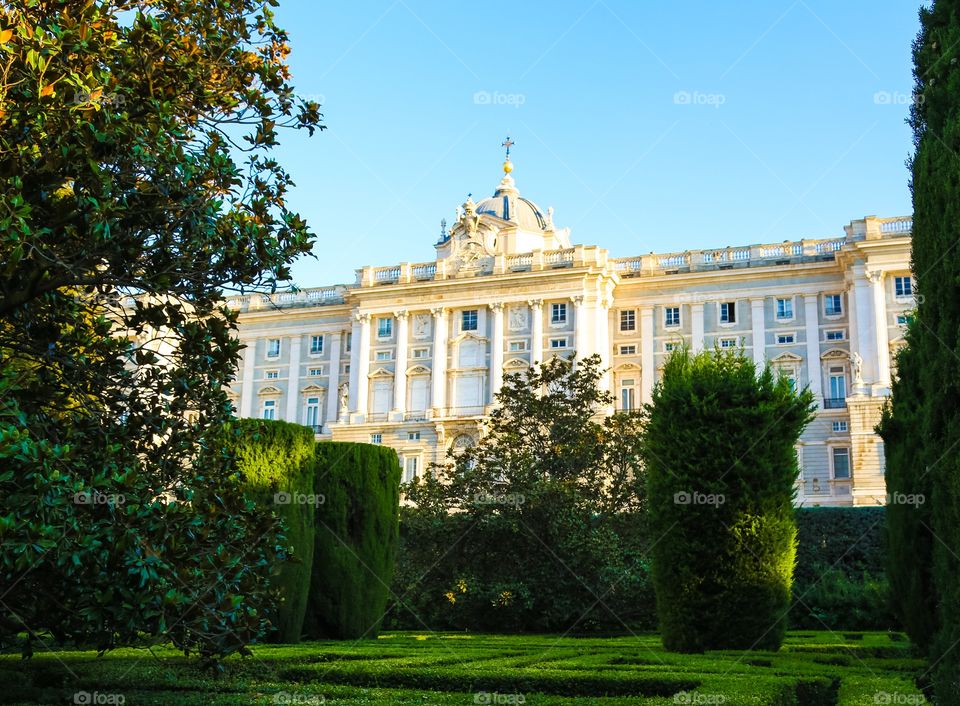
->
[[398, 355, 646, 630]]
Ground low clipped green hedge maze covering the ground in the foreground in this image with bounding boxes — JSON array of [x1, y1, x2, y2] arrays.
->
[[0, 632, 926, 706]]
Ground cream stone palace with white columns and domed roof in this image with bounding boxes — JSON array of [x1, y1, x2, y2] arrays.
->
[[230, 160, 915, 505]]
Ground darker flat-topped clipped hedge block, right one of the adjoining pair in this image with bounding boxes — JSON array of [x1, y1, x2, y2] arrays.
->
[[304, 442, 400, 639]]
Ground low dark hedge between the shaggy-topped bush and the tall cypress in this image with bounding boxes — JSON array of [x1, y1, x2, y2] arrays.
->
[[790, 507, 896, 630]]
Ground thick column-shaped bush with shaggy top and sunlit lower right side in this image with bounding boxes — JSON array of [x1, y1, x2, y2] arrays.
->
[[644, 350, 813, 652]]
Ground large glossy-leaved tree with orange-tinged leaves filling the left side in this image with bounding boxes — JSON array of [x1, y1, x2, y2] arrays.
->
[[0, 0, 320, 659]]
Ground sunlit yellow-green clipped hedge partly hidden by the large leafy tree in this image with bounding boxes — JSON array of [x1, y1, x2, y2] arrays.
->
[[225, 419, 317, 642]]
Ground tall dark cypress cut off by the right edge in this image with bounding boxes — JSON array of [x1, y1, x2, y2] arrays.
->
[[880, 0, 960, 704]]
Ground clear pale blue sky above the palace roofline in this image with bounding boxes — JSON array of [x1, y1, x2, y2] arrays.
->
[[277, 0, 919, 287]]
